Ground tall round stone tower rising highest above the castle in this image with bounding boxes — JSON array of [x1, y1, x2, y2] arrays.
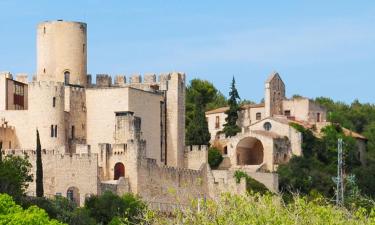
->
[[37, 20, 87, 86]]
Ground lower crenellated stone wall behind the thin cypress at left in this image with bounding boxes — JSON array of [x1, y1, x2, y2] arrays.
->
[[1, 150, 98, 205]]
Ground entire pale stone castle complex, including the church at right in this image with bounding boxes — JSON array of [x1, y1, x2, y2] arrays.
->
[[0, 20, 365, 205]]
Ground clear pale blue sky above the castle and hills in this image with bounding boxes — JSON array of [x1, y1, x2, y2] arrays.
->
[[0, 0, 375, 103]]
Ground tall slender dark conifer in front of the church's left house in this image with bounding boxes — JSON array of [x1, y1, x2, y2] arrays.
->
[[223, 77, 241, 137]]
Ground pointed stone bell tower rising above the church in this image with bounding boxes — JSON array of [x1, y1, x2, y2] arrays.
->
[[264, 72, 285, 117]]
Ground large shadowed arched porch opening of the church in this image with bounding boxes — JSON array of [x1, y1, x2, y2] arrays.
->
[[236, 137, 264, 165]]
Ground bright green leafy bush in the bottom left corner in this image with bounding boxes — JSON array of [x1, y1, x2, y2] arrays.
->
[[0, 194, 62, 225]]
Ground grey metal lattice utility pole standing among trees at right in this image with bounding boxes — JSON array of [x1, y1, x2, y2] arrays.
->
[[336, 138, 344, 206]]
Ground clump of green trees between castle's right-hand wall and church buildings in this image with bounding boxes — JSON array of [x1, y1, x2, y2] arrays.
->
[[185, 79, 226, 145]]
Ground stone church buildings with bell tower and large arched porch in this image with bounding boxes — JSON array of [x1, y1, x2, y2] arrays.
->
[[206, 72, 366, 178]]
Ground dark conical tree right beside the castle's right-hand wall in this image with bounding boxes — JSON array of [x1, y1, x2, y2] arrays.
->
[[186, 95, 211, 145]]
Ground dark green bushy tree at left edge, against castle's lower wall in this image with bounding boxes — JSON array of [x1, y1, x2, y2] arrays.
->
[[0, 155, 33, 202]]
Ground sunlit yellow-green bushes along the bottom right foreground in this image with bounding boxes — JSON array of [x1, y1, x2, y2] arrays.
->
[[151, 194, 375, 225]]
